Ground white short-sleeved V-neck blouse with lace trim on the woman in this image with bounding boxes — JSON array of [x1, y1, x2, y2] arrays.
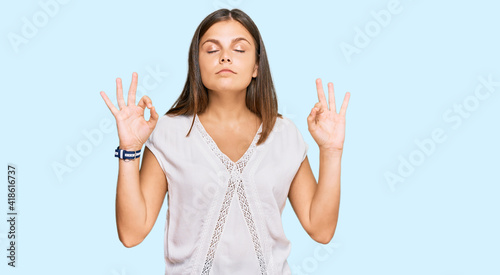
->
[[146, 115, 308, 275]]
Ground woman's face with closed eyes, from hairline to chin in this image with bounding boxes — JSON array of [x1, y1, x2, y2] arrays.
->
[[199, 20, 258, 95]]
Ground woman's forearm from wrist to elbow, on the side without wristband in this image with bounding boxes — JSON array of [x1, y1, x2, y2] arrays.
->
[[310, 150, 342, 241]]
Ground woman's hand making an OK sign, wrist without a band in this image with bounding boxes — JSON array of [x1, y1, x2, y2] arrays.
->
[[307, 78, 351, 153]]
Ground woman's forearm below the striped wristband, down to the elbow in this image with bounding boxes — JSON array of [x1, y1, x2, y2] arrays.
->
[[116, 158, 146, 246]]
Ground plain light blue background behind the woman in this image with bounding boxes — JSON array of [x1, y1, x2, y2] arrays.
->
[[0, 0, 500, 275]]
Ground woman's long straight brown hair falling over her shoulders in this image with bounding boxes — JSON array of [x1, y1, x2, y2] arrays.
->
[[165, 9, 282, 145]]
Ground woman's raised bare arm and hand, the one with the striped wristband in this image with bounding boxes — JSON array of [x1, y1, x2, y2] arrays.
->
[[101, 72, 167, 247]]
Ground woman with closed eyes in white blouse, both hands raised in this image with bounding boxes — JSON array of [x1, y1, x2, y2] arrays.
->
[[97, 9, 350, 274]]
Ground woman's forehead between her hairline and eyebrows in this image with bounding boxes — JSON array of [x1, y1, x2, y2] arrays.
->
[[200, 20, 254, 45]]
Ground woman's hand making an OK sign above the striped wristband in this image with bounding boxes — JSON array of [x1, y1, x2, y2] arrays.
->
[[101, 72, 159, 151]]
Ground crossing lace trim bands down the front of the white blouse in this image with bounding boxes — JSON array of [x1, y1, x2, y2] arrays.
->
[[195, 115, 267, 275]]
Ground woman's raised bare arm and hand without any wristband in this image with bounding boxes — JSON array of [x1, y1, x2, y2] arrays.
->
[[288, 79, 350, 244]]
